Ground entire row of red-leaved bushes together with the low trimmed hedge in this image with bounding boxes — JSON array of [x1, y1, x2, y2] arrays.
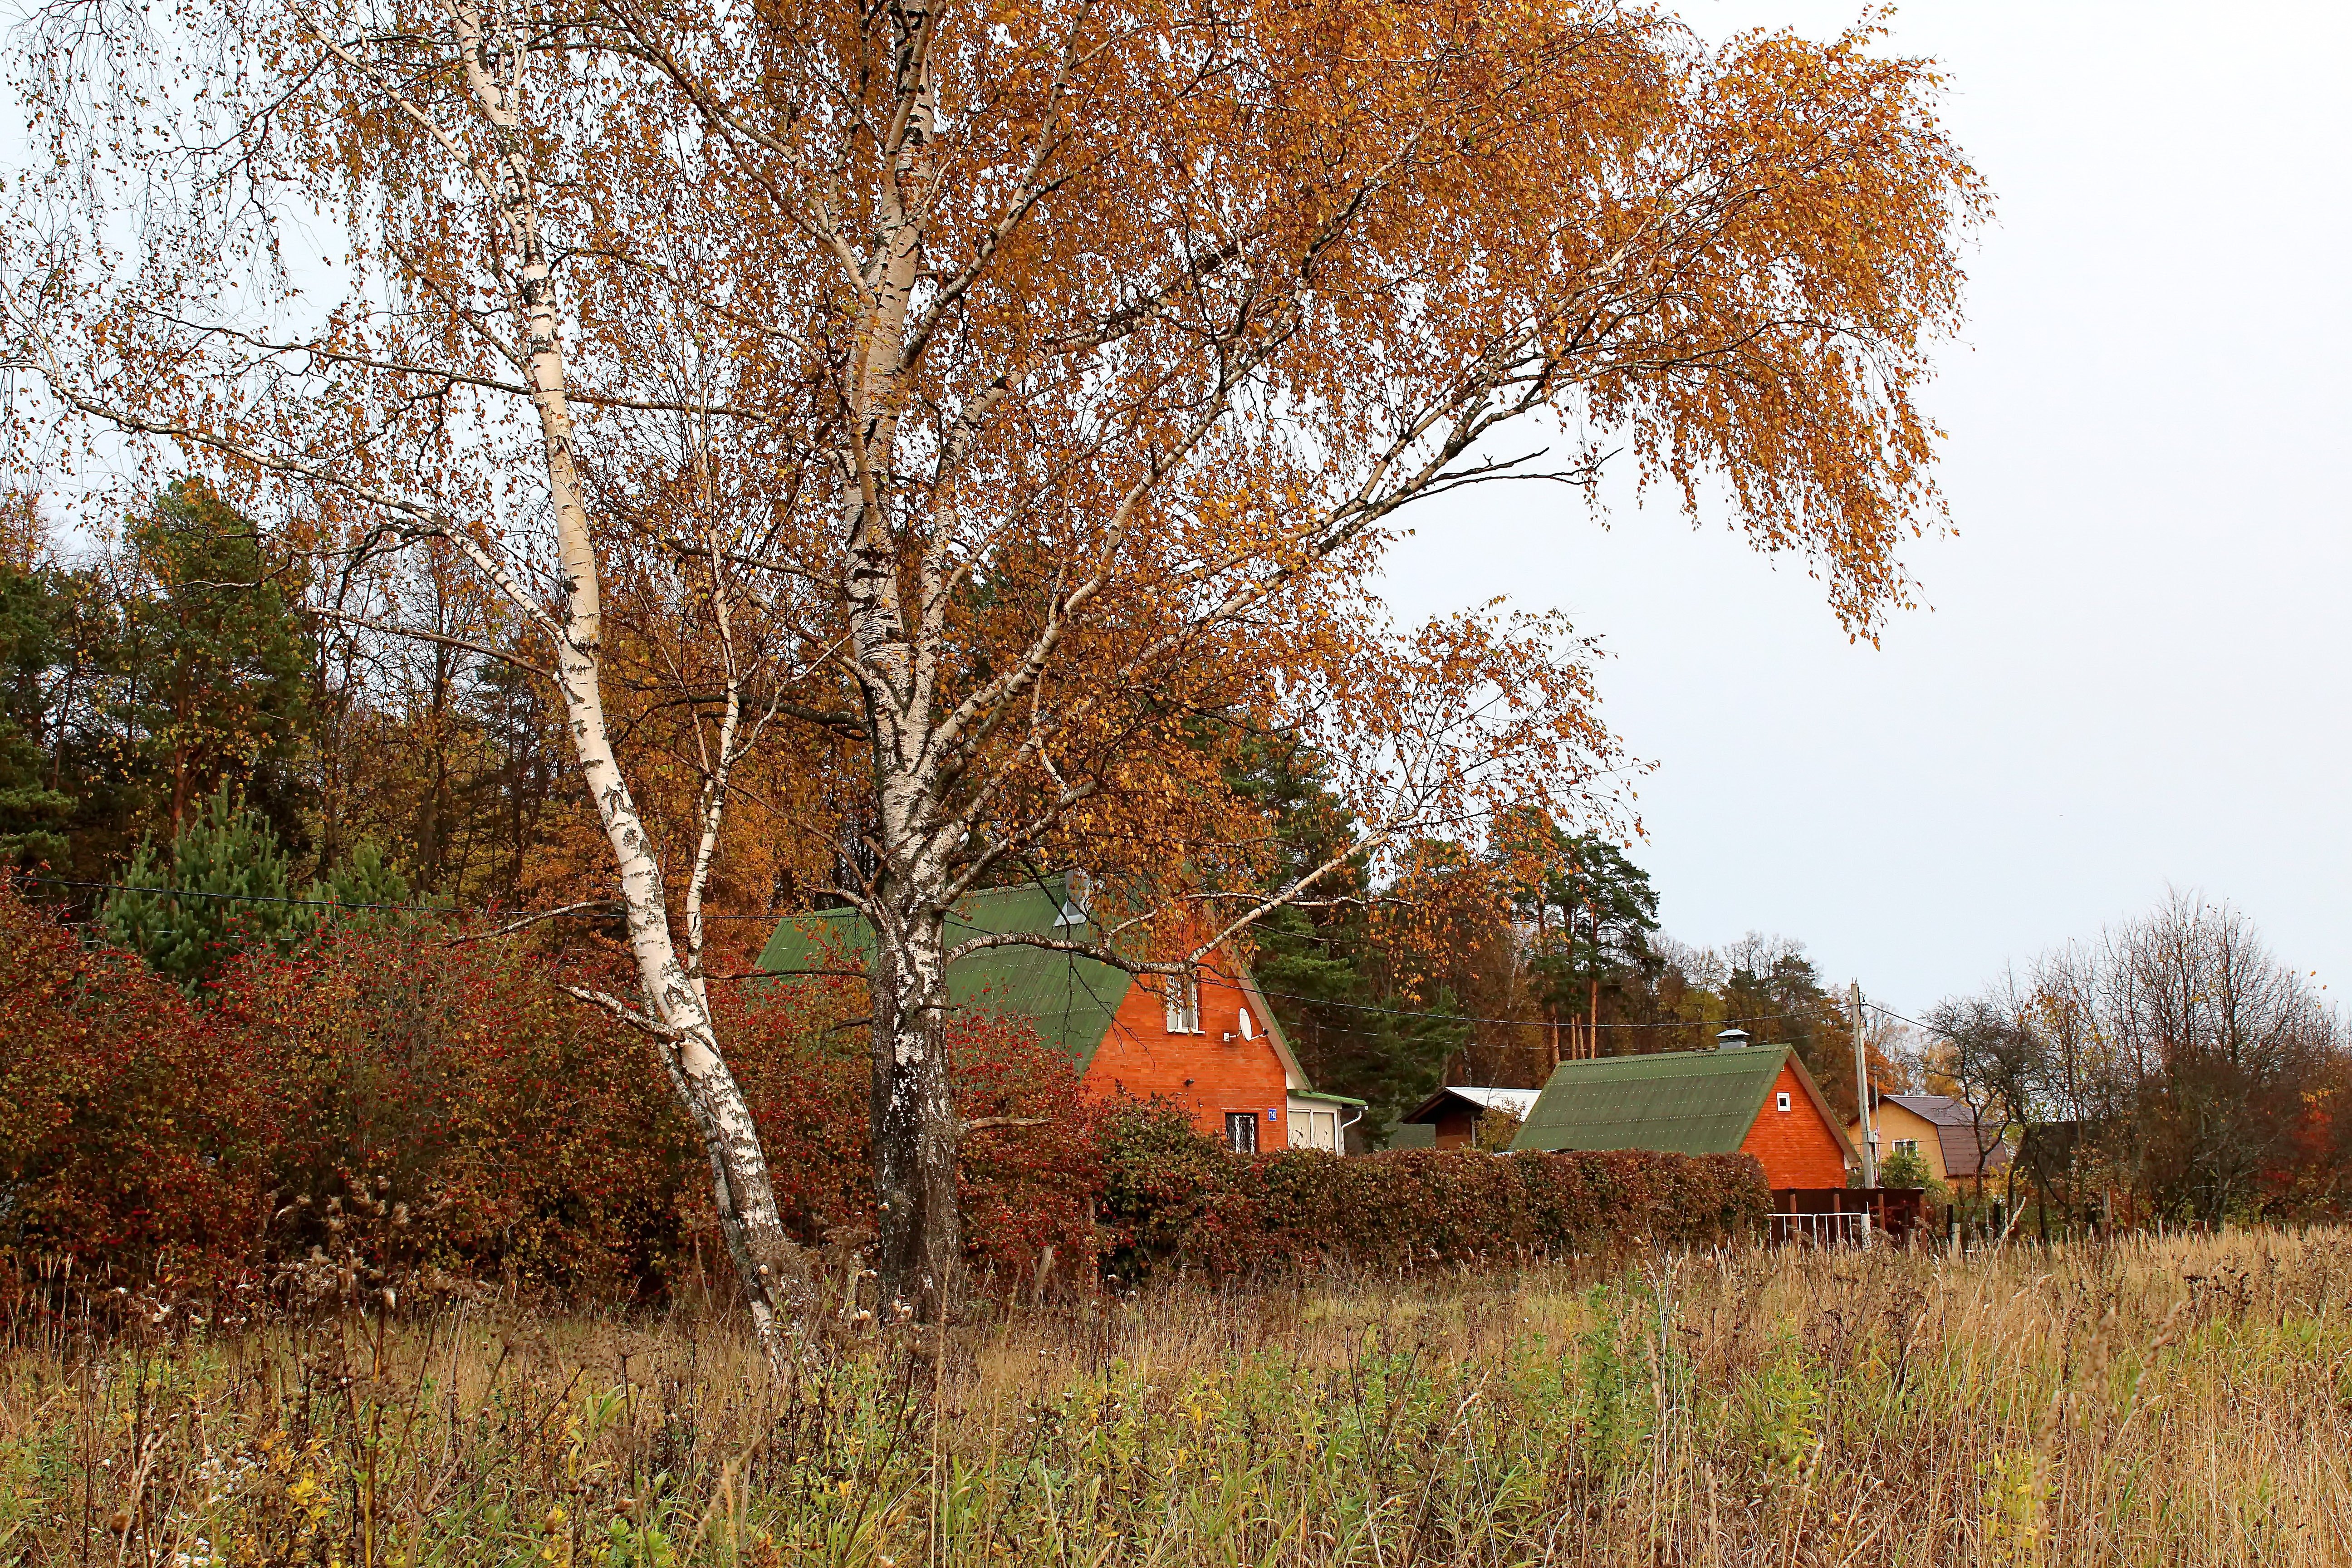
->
[[0, 889, 1769, 1298]]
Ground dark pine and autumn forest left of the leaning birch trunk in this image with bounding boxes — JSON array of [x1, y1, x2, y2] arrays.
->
[[0, 482, 564, 905]]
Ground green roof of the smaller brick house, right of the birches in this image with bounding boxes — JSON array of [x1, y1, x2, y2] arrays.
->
[[1510, 1046, 1790, 1154]]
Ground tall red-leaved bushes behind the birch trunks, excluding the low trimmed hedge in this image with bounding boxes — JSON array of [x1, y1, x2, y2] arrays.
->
[[0, 891, 1098, 1295]]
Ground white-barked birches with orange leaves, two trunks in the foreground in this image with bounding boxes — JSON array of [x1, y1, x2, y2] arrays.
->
[[7, 0, 1983, 1333]]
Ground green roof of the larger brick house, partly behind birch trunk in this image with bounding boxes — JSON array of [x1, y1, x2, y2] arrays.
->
[[760, 877, 1136, 1072]]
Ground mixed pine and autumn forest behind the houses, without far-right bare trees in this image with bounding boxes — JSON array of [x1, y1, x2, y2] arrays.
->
[[0, 482, 1893, 1124]]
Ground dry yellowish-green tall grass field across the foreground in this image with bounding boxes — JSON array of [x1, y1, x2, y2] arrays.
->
[[0, 1230, 2352, 1568]]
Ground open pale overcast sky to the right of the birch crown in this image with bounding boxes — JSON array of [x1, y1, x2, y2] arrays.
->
[[1388, 0, 2352, 1011]]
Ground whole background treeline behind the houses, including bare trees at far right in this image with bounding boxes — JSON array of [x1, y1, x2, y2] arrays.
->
[[0, 482, 2352, 1215]]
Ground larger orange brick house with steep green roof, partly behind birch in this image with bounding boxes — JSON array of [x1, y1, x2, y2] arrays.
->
[[760, 877, 1364, 1152]]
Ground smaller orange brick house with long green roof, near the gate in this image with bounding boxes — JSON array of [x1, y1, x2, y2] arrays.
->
[[1510, 1029, 1861, 1192]]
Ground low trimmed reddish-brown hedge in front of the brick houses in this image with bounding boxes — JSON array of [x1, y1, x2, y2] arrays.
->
[[1103, 1107, 1771, 1279]]
